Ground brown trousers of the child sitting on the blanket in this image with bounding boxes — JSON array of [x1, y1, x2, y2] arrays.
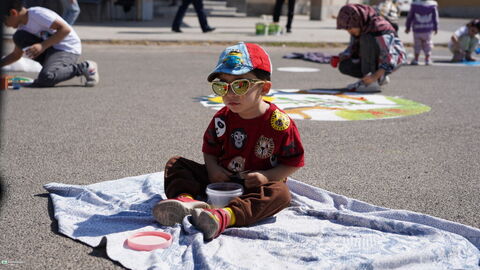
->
[[165, 156, 291, 226]]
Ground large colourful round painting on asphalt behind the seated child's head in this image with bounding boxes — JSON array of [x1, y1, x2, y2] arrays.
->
[[200, 89, 430, 121]]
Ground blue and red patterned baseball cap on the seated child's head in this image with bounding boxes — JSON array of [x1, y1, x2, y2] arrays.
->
[[207, 42, 272, 82]]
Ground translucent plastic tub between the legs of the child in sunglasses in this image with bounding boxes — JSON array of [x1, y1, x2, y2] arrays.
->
[[205, 182, 243, 208]]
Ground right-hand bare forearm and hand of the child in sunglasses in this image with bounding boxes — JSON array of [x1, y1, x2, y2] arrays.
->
[[245, 164, 300, 188]]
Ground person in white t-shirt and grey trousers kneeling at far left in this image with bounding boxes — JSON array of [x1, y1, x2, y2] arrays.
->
[[0, 0, 99, 87]]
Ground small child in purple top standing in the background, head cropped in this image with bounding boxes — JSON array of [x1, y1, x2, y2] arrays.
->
[[405, 0, 438, 66]]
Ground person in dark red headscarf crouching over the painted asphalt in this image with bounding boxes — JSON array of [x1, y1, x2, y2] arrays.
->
[[337, 4, 406, 92]]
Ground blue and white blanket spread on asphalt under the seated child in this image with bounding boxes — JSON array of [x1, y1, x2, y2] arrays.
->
[[44, 172, 480, 269]]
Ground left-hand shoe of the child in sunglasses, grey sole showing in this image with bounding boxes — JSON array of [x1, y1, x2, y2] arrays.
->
[[152, 197, 210, 226]]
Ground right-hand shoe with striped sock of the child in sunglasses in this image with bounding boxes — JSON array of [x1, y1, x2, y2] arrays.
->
[[192, 208, 230, 241]]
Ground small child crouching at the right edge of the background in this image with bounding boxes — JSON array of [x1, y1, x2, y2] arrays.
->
[[448, 19, 480, 62]]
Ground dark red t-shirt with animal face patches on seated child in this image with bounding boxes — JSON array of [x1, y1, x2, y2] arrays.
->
[[202, 103, 304, 172]]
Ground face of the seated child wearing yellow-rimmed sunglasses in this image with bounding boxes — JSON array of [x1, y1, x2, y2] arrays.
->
[[218, 73, 270, 118]]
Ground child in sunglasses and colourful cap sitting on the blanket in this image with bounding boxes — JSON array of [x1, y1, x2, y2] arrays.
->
[[153, 42, 304, 240]]
